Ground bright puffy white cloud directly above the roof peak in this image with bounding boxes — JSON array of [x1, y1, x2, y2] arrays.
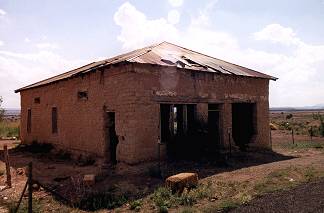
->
[[114, 2, 178, 50]]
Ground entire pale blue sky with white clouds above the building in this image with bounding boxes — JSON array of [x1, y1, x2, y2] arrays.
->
[[0, 0, 324, 108]]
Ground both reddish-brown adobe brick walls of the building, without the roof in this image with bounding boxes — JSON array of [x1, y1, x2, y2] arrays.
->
[[21, 64, 269, 163]]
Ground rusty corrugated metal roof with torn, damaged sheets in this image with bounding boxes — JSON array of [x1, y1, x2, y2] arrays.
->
[[15, 42, 278, 93]]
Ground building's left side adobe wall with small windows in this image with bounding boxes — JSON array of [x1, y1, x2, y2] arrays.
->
[[21, 67, 140, 161]]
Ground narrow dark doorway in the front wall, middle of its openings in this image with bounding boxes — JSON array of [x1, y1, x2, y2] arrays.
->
[[208, 104, 220, 153]]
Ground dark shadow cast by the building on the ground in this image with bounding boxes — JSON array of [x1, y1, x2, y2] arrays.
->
[[1, 143, 293, 210]]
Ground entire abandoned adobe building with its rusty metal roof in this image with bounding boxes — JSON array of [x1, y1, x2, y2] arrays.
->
[[15, 42, 276, 164]]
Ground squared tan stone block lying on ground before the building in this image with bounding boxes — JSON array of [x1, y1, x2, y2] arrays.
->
[[165, 173, 198, 193]]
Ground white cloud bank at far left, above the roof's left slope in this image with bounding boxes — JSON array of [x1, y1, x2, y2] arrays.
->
[[0, 50, 89, 107]]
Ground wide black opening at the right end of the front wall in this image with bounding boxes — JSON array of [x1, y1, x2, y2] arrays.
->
[[232, 103, 256, 150]]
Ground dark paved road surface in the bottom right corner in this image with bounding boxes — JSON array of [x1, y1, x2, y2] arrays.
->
[[230, 179, 324, 213]]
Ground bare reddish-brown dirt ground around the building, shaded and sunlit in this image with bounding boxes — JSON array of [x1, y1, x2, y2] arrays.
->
[[0, 110, 324, 212]]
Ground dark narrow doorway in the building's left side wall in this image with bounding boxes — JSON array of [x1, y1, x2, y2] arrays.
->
[[106, 112, 118, 165]]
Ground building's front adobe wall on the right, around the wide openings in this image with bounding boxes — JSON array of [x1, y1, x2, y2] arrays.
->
[[130, 65, 270, 159]]
